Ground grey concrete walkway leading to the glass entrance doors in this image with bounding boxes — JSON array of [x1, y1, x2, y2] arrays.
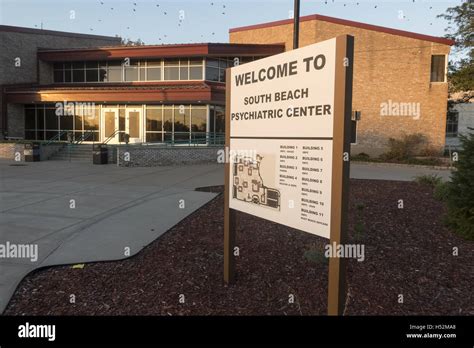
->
[[0, 161, 224, 313]]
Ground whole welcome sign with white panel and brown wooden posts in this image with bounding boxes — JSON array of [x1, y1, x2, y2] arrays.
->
[[224, 35, 354, 315]]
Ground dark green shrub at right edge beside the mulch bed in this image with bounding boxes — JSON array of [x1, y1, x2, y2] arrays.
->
[[447, 133, 474, 240]]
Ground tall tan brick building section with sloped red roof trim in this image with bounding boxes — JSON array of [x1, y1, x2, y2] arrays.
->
[[229, 15, 454, 155]]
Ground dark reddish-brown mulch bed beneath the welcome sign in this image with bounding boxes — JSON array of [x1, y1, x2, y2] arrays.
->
[[4, 180, 474, 315]]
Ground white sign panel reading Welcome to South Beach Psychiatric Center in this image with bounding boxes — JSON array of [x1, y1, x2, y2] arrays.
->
[[229, 39, 336, 238]]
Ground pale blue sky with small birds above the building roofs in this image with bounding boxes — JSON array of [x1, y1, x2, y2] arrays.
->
[[0, 0, 462, 45]]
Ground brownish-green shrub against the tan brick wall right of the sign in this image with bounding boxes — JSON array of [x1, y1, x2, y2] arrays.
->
[[380, 133, 426, 161]]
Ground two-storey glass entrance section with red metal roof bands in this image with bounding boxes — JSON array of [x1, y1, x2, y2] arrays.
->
[[3, 30, 284, 144]]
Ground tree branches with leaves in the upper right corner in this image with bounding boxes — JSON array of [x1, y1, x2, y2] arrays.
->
[[438, 0, 474, 92]]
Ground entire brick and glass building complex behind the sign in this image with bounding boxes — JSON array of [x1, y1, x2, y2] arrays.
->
[[0, 15, 453, 155]]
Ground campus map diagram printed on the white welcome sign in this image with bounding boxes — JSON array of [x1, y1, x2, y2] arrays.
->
[[232, 155, 280, 210]]
